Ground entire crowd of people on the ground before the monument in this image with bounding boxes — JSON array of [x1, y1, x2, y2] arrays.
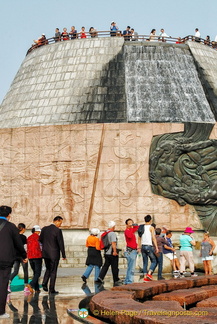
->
[[0, 206, 215, 319]]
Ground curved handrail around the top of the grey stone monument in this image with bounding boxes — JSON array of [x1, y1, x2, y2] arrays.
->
[[26, 30, 217, 55]]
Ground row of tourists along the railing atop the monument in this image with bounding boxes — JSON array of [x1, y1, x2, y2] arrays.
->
[[29, 21, 217, 51]]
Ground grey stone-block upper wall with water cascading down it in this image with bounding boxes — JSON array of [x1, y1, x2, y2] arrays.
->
[[0, 37, 217, 128]]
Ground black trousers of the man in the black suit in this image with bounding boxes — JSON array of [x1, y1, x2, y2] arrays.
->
[[42, 258, 59, 291]]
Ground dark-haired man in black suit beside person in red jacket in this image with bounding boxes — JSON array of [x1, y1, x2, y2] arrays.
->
[[39, 216, 66, 294]]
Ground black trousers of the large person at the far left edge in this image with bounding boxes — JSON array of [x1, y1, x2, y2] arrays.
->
[[0, 267, 12, 315]]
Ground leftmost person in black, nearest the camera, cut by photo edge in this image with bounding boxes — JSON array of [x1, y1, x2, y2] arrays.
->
[[0, 206, 27, 319]]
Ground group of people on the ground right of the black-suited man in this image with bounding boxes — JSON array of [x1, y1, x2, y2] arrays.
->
[[81, 215, 215, 286]]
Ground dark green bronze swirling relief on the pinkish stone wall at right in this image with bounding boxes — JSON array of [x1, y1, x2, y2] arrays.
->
[[149, 124, 217, 234]]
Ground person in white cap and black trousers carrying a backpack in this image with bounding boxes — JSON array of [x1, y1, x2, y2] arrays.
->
[[96, 221, 122, 286]]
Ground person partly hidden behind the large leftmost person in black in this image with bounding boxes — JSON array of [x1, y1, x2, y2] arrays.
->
[[8, 223, 29, 292]]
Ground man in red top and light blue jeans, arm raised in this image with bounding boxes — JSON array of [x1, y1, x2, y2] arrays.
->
[[124, 218, 139, 285]]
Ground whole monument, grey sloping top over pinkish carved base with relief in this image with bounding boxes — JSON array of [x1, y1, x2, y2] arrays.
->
[[0, 37, 217, 266]]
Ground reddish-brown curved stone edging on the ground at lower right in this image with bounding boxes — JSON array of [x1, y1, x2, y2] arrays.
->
[[90, 276, 217, 324]]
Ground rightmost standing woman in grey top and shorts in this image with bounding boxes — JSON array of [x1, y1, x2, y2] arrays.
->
[[201, 232, 215, 275]]
